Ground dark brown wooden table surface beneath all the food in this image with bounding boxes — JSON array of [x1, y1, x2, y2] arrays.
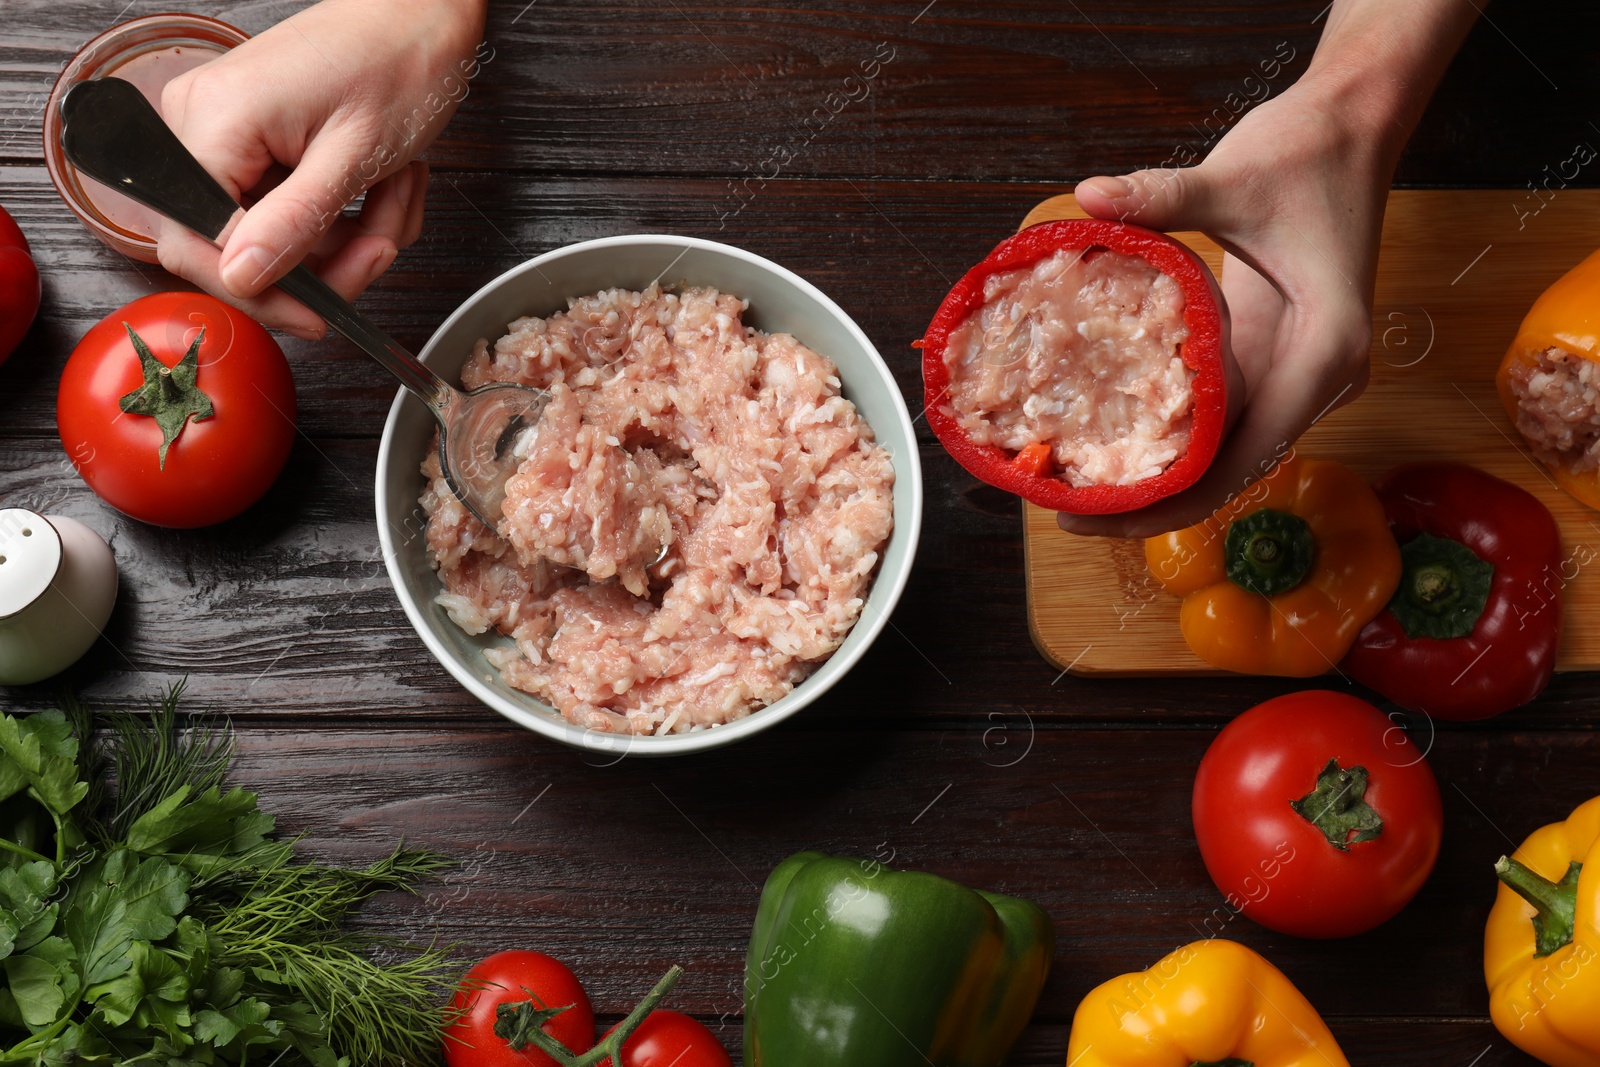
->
[[0, 0, 1600, 1067]]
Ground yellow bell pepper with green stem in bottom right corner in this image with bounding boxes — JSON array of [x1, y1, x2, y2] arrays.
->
[[1483, 797, 1600, 1067]]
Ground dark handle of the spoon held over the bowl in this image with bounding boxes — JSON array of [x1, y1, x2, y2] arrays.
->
[[61, 78, 454, 414]]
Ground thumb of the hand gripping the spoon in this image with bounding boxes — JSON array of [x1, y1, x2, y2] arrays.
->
[[219, 130, 368, 298]]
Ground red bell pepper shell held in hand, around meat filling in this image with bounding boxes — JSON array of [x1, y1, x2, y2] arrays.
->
[[922, 219, 1237, 515]]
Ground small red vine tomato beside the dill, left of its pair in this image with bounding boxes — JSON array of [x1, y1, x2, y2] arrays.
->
[[445, 949, 595, 1067]]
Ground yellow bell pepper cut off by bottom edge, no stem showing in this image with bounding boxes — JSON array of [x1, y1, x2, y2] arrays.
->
[[1067, 939, 1349, 1067]]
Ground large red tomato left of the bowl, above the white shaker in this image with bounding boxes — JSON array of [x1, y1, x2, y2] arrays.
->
[[56, 293, 294, 526]]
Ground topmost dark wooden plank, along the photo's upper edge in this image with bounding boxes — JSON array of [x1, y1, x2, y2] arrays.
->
[[0, 0, 1600, 187]]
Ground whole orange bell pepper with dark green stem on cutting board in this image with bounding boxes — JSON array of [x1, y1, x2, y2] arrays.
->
[[1144, 453, 1400, 678]]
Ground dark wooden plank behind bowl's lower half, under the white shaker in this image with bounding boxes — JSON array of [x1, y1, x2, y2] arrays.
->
[[9, 437, 1600, 726]]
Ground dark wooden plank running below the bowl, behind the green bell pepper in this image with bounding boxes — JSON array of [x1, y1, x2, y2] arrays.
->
[[37, 723, 1561, 1067]]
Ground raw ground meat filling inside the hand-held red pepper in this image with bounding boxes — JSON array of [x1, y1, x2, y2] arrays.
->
[[944, 250, 1195, 486]]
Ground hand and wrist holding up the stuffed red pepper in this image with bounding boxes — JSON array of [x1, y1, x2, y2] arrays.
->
[[1058, 0, 1474, 537]]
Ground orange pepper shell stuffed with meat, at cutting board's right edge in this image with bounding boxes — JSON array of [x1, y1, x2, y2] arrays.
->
[[1494, 251, 1600, 509]]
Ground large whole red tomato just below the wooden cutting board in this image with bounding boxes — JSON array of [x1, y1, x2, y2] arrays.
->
[[1194, 691, 1443, 937]]
